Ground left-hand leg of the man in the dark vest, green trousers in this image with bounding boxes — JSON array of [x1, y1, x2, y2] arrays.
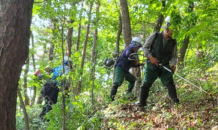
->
[[139, 67, 158, 109]]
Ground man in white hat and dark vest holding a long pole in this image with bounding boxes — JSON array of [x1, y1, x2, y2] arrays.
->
[[139, 16, 179, 111]]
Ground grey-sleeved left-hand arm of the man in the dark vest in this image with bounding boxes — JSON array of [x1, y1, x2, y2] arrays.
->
[[142, 32, 157, 58]]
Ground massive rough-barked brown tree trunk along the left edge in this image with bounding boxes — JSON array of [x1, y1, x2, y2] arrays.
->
[[0, 0, 33, 130]]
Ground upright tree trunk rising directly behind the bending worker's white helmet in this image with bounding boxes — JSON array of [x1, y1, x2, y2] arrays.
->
[[120, 0, 132, 47]]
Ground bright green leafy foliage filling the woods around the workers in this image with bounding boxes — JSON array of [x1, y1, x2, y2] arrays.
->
[[16, 0, 218, 130]]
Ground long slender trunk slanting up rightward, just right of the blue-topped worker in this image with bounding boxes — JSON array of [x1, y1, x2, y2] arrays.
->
[[77, 2, 93, 94]]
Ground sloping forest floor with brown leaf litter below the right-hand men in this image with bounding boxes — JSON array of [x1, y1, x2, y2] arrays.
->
[[102, 89, 218, 130]]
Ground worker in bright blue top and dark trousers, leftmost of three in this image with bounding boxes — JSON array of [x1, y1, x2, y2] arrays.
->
[[40, 55, 72, 121]]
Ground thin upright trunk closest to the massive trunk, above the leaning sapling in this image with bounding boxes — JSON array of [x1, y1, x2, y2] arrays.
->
[[23, 58, 29, 105]]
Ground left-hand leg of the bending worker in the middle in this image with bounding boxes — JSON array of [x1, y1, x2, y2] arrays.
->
[[110, 66, 124, 101]]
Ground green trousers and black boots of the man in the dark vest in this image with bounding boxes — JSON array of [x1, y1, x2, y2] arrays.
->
[[139, 67, 178, 106]]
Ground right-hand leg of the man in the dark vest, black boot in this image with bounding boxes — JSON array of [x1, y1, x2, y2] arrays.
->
[[160, 68, 179, 103]]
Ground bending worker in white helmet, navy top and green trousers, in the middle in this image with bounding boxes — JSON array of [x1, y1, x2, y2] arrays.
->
[[110, 37, 144, 101]]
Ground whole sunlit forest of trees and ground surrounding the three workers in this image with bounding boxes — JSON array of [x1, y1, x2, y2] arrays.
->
[[0, 0, 218, 130]]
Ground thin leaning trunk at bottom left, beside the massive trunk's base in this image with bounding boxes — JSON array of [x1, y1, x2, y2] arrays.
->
[[17, 88, 29, 130]]
